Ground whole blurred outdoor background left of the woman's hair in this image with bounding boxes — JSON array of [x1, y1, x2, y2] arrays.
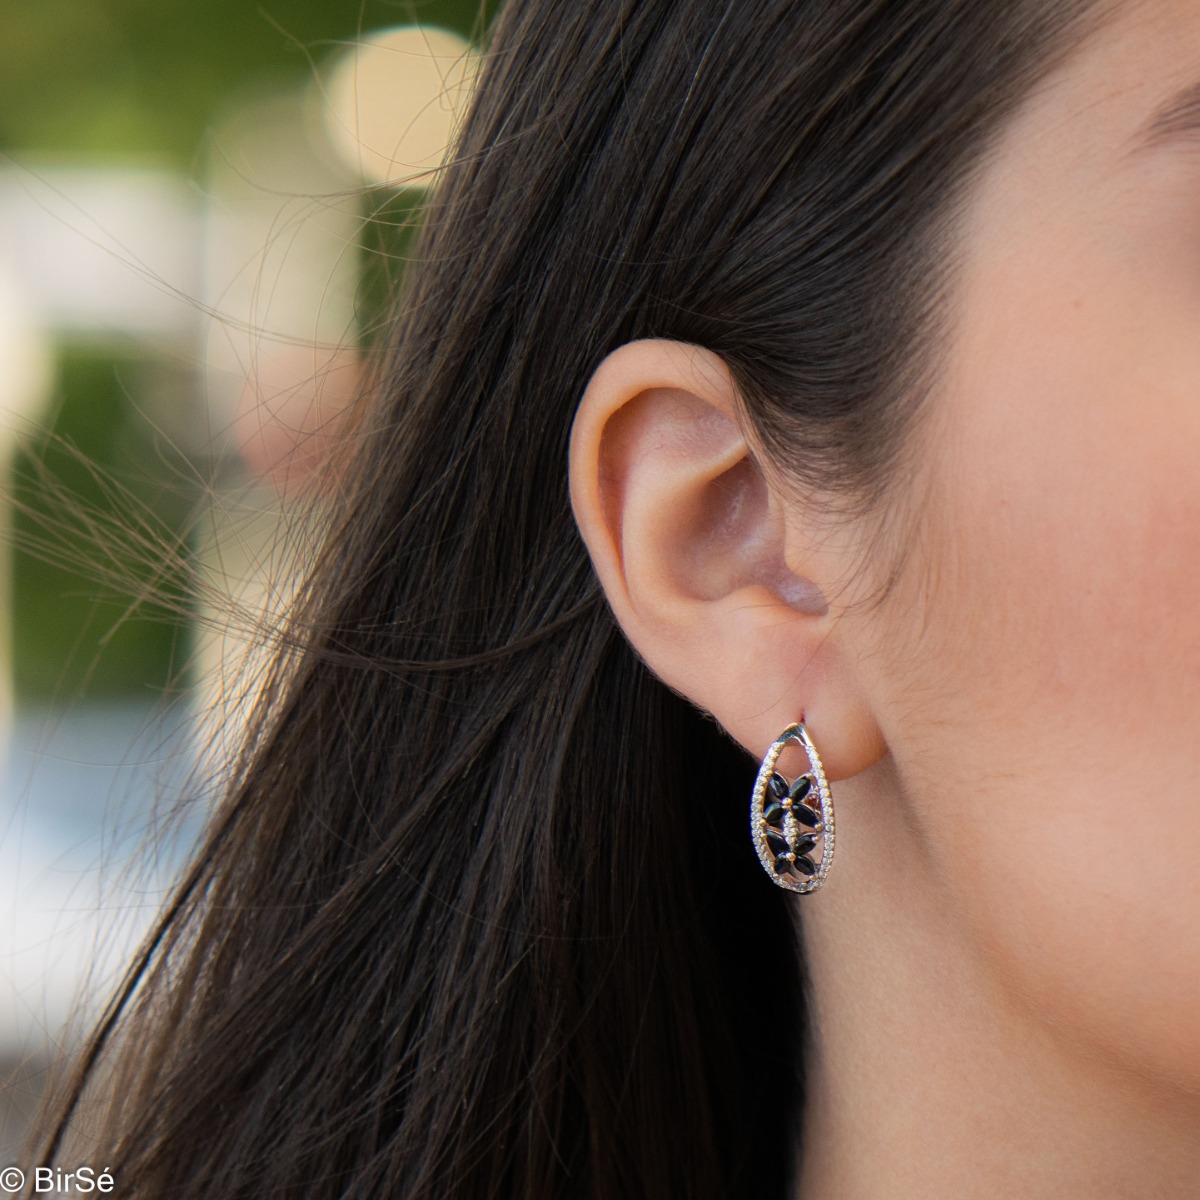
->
[[0, 0, 511, 1142]]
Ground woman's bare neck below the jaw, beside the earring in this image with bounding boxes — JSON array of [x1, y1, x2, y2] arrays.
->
[[798, 758, 1200, 1200]]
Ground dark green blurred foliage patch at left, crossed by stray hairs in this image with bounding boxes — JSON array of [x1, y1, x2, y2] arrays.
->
[[12, 341, 191, 702]]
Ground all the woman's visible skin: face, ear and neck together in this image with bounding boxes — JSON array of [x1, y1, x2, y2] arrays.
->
[[571, 0, 1200, 1200]]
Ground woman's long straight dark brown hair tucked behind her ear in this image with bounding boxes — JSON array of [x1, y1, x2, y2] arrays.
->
[[30, 0, 1113, 1200]]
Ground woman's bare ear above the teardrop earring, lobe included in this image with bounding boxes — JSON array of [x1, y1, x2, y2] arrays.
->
[[570, 341, 886, 779]]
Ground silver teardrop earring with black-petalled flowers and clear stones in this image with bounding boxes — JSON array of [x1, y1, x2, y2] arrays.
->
[[750, 718, 834, 893]]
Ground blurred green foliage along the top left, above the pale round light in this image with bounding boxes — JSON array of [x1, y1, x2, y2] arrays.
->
[[0, 0, 496, 170]]
